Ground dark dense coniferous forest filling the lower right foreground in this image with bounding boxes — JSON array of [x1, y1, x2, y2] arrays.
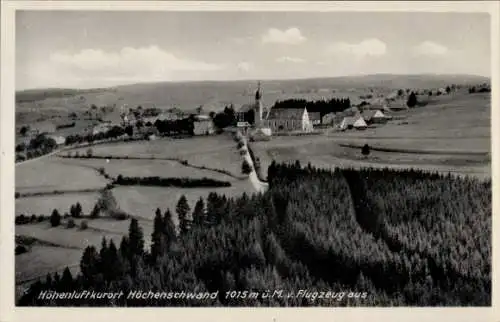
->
[[18, 161, 492, 306]]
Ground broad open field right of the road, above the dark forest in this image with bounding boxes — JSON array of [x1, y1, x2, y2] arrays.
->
[[252, 93, 491, 178]]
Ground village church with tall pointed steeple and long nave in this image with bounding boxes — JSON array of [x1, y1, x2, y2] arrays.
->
[[238, 82, 313, 135]]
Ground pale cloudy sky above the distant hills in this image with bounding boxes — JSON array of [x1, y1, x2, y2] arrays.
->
[[16, 11, 490, 90]]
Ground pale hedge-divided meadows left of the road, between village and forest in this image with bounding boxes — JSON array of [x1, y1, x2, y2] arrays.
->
[[16, 135, 255, 285]]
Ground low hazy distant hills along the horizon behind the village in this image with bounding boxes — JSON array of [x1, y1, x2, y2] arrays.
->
[[16, 74, 489, 115]]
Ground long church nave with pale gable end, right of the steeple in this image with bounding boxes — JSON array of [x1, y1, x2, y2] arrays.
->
[[265, 107, 313, 132]]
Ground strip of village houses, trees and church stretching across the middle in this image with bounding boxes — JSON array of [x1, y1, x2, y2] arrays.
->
[[16, 82, 484, 161]]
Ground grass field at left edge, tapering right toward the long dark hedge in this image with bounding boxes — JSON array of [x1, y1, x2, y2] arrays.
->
[[15, 156, 107, 193]]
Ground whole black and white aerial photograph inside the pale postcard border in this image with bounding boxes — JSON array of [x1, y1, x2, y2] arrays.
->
[[2, 1, 498, 314]]
